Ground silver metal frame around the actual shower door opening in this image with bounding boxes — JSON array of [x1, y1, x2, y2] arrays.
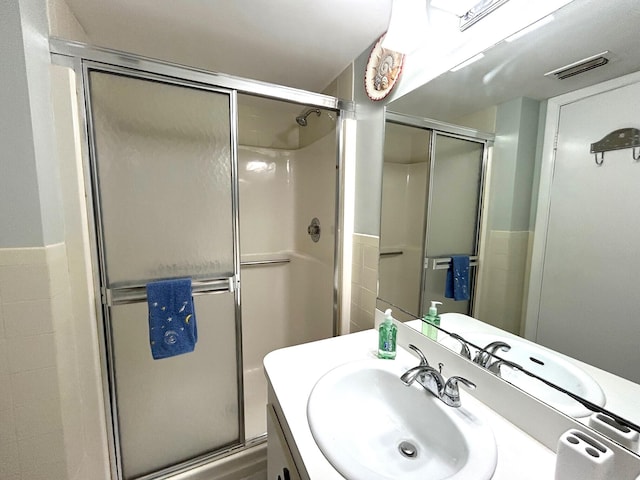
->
[[49, 38, 355, 480]]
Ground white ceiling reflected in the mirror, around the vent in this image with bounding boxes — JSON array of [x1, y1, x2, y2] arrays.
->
[[388, 0, 640, 123]]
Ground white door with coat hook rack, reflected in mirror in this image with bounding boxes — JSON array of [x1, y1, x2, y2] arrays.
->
[[536, 83, 640, 382]]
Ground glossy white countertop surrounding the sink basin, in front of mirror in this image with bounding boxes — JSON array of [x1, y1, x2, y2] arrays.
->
[[264, 330, 556, 480]]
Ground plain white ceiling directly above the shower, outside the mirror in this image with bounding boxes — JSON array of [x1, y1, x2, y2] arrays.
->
[[66, 0, 391, 92]]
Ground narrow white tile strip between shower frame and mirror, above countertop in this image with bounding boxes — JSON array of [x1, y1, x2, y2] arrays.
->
[[350, 233, 380, 333]]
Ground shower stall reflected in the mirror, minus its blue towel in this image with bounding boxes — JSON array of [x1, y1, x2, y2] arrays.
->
[[378, 113, 492, 317]]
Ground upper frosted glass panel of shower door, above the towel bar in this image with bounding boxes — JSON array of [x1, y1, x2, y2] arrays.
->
[[89, 71, 234, 288]]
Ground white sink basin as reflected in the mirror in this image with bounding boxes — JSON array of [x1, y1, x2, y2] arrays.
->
[[463, 332, 606, 418]]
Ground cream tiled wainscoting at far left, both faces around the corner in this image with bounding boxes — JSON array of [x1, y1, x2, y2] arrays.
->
[[0, 244, 106, 480]]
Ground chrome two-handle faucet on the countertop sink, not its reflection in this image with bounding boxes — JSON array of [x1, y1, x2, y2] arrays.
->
[[400, 344, 476, 408]]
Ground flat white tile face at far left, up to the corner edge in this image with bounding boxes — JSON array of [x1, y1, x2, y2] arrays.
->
[[0, 246, 68, 480]]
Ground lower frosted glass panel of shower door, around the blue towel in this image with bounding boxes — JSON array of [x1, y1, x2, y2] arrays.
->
[[111, 293, 239, 479]]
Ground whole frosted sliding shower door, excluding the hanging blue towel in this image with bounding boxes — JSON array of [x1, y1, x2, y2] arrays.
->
[[84, 66, 244, 479]]
